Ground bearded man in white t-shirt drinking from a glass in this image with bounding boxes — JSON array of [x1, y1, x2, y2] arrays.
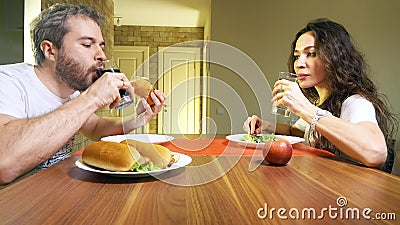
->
[[0, 4, 166, 185]]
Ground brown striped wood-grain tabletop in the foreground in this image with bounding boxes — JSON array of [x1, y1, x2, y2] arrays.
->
[[0, 156, 400, 224]]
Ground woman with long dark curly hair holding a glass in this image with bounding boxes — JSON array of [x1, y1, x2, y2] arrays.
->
[[243, 19, 398, 172]]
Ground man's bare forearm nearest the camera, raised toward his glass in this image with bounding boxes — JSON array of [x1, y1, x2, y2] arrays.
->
[[0, 95, 97, 185]]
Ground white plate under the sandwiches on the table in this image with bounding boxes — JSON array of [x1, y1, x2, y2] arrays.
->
[[75, 152, 192, 177]]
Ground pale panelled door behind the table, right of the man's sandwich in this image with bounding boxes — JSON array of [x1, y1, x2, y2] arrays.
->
[[158, 47, 201, 134]]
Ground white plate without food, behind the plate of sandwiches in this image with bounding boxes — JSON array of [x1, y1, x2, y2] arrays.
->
[[101, 134, 174, 144]]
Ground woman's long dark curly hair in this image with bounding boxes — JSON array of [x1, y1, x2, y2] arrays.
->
[[288, 19, 398, 169]]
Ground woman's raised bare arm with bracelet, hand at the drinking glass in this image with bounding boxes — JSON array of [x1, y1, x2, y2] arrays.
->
[[273, 78, 387, 167]]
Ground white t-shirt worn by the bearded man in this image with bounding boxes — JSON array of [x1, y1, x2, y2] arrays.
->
[[0, 63, 79, 171]]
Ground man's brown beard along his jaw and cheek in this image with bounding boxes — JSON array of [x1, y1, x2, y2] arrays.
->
[[56, 50, 98, 91]]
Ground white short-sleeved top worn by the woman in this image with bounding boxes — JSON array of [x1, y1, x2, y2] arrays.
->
[[294, 94, 378, 161]]
